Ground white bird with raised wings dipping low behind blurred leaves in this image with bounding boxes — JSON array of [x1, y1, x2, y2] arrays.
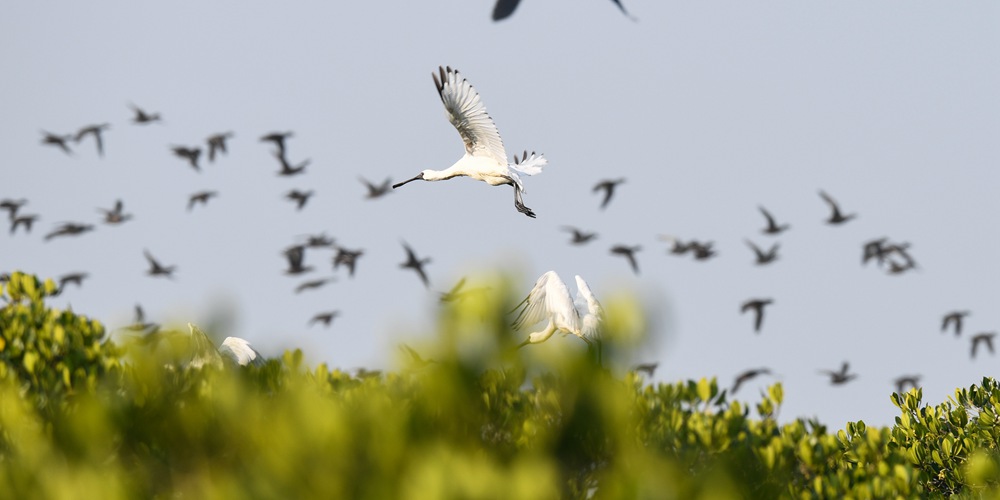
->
[[514, 271, 604, 362]]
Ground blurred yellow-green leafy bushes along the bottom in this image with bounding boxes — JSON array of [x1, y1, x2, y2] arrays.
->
[[0, 273, 1000, 499]]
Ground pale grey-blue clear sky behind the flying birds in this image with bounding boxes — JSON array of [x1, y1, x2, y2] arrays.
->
[[0, 0, 1000, 427]]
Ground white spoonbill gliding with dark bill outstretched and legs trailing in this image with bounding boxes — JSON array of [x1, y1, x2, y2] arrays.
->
[[392, 66, 547, 217]]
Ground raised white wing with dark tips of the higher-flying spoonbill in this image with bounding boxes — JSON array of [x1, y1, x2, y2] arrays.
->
[[431, 66, 507, 165]]
